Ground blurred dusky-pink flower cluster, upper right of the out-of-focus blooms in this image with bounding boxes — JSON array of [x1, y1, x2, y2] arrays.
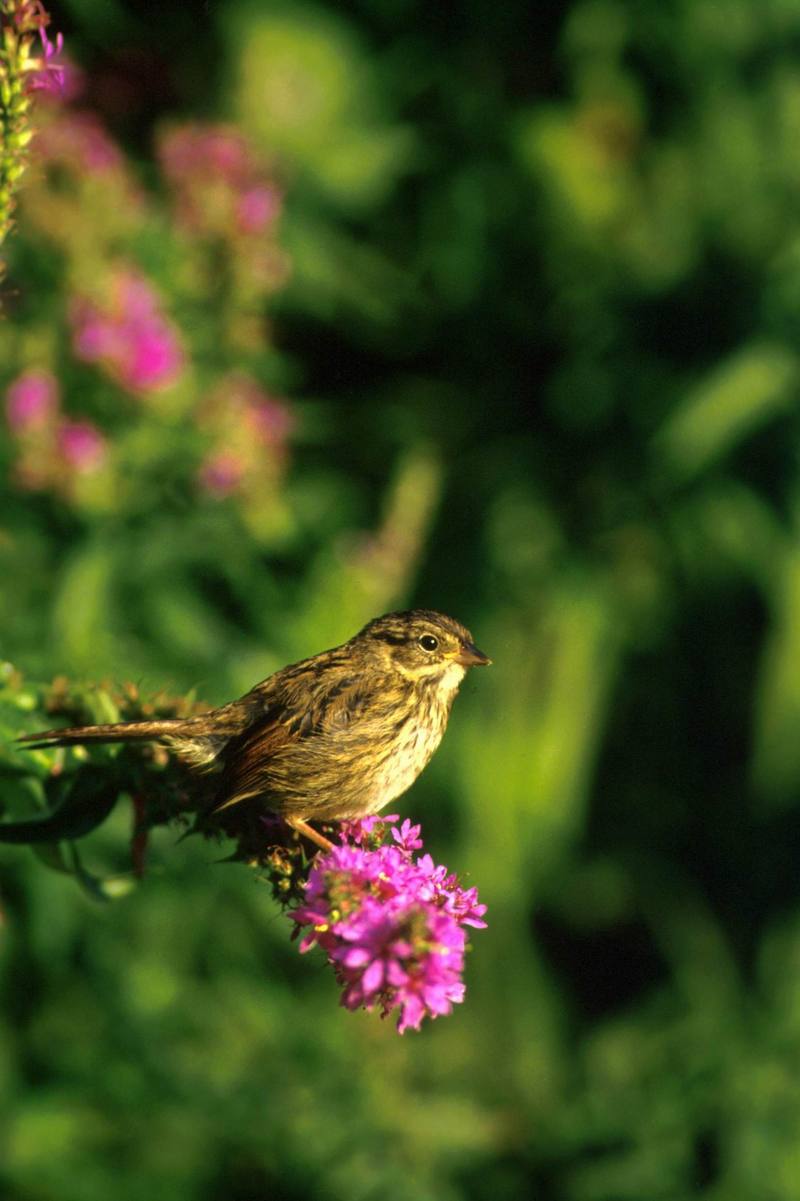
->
[[159, 124, 282, 234]]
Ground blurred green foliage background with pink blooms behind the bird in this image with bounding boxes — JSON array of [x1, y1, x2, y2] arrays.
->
[[0, 0, 800, 1201]]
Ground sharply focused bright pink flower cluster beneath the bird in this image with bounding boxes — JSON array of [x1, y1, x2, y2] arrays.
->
[[289, 817, 486, 1034]]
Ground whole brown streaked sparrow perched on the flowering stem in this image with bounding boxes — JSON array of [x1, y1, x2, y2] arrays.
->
[[20, 609, 491, 849]]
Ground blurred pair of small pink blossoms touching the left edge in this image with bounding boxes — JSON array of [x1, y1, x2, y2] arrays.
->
[[6, 369, 108, 490]]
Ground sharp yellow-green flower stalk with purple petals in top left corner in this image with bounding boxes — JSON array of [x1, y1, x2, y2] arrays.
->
[[0, 0, 64, 267]]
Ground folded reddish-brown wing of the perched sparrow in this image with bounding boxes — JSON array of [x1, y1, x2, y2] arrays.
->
[[214, 663, 368, 812]]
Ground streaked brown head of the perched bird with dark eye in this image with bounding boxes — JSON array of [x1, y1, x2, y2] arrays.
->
[[353, 609, 491, 687]]
